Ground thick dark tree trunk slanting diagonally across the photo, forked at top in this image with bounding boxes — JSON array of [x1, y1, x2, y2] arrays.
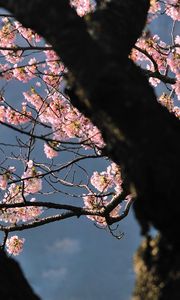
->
[[0, 0, 180, 298]]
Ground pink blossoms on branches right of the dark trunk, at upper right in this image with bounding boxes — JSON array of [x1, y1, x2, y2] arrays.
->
[[131, 0, 180, 116]]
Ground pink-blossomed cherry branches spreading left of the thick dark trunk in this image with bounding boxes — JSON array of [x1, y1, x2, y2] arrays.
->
[[0, 4, 135, 255]]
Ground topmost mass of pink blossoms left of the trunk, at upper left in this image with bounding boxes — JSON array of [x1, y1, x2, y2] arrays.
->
[[0, 18, 62, 87]]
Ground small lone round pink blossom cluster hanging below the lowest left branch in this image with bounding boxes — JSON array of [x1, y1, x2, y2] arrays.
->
[[6, 235, 25, 255]]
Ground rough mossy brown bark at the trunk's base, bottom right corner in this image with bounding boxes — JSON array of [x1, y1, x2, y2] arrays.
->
[[132, 235, 180, 300]]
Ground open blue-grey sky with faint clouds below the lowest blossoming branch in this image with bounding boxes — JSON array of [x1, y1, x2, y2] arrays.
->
[[0, 5, 177, 300]]
